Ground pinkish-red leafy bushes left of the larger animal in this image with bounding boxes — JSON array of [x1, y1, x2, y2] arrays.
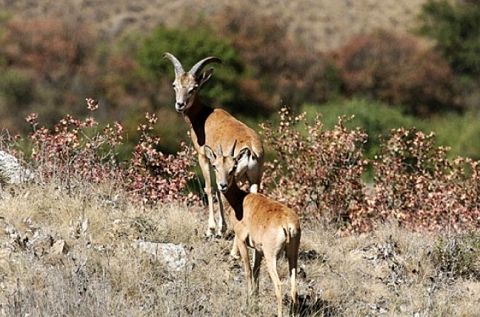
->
[[27, 100, 199, 204]]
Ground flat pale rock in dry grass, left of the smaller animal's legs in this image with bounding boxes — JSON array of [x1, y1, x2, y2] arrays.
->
[[134, 241, 187, 271]]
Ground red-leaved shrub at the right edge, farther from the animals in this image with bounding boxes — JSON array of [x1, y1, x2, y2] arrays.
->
[[368, 129, 480, 230]]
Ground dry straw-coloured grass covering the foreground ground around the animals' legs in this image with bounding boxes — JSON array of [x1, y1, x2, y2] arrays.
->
[[0, 186, 480, 316]]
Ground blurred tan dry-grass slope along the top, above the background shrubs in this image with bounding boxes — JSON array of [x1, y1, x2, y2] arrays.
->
[[0, 0, 425, 50]]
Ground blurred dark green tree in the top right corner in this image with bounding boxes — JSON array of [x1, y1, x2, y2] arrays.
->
[[420, 0, 480, 77]]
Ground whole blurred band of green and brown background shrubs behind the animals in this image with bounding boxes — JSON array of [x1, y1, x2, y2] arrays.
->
[[0, 1, 480, 159]]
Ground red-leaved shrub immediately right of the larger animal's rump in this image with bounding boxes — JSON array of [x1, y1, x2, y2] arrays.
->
[[262, 108, 367, 229]]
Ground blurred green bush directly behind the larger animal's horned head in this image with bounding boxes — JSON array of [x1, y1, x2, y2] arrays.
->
[[138, 27, 246, 111]]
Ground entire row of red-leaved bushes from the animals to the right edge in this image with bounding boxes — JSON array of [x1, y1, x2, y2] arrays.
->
[[263, 110, 480, 232]]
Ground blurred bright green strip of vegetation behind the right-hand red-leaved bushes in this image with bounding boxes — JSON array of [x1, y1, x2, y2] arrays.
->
[[302, 99, 480, 159]]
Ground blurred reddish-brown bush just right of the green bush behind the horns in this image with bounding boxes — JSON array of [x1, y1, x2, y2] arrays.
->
[[212, 5, 339, 110]]
